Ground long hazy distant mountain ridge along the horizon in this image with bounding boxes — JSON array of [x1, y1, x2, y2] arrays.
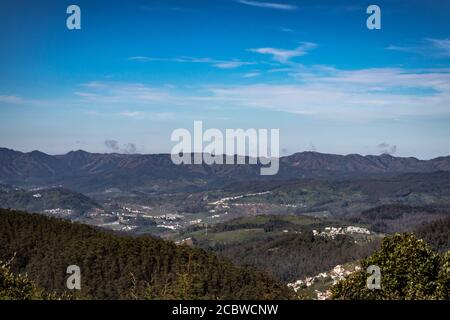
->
[[0, 148, 450, 192]]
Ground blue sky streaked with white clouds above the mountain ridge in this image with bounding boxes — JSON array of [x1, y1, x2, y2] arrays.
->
[[0, 0, 450, 159]]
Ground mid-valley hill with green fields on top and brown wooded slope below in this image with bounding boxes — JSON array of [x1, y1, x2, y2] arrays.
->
[[188, 215, 380, 282]]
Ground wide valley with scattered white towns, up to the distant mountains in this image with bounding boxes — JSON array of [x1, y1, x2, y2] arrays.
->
[[0, 152, 450, 299]]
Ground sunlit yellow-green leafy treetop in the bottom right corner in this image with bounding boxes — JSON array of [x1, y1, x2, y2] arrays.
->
[[332, 234, 450, 300]]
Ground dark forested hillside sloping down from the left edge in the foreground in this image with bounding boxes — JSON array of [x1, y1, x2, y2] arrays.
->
[[0, 209, 291, 299]]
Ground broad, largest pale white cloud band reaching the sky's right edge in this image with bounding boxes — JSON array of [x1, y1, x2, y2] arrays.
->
[[198, 67, 450, 121]]
